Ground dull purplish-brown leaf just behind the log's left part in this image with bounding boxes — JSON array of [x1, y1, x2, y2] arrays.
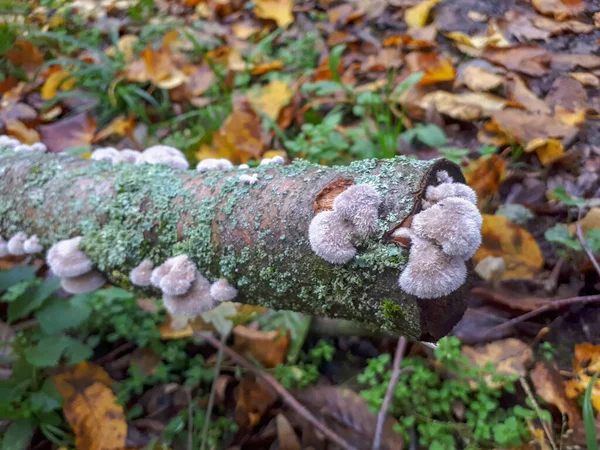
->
[[39, 113, 96, 153]]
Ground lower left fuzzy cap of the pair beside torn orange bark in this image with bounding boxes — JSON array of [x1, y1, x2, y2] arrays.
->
[[308, 211, 356, 264]]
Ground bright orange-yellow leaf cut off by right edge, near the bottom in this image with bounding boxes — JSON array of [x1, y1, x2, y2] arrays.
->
[[565, 343, 600, 411]]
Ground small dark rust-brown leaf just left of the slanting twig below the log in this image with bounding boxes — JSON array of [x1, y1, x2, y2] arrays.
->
[[234, 374, 277, 430]]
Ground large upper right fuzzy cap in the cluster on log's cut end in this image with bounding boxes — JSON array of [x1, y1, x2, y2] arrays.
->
[[411, 197, 483, 260]]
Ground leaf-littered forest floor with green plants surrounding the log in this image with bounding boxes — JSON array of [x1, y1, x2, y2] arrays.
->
[[0, 0, 600, 450]]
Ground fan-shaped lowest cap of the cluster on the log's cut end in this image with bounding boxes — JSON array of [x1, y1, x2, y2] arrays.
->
[[398, 236, 467, 299]]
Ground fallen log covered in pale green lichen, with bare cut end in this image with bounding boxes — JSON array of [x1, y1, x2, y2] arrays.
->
[[0, 150, 468, 340]]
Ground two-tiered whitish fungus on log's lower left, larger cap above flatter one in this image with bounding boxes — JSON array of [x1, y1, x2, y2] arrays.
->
[[46, 237, 106, 294]]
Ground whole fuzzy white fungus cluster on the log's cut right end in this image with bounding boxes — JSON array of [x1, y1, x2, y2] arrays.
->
[[393, 171, 483, 298]]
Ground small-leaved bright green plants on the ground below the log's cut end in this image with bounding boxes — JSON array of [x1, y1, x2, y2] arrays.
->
[[358, 337, 535, 450]]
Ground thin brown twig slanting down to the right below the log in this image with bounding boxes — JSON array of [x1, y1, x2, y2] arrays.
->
[[195, 333, 357, 450]]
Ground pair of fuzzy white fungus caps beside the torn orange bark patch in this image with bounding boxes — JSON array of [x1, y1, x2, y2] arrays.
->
[[308, 184, 383, 264]]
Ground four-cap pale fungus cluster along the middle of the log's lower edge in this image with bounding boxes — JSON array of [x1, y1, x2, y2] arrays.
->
[[129, 255, 238, 317]]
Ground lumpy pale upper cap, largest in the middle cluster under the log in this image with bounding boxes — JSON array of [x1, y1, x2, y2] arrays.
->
[[150, 255, 197, 295]]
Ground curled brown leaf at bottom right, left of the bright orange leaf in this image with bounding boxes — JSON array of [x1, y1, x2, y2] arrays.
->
[[529, 362, 582, 428]]
